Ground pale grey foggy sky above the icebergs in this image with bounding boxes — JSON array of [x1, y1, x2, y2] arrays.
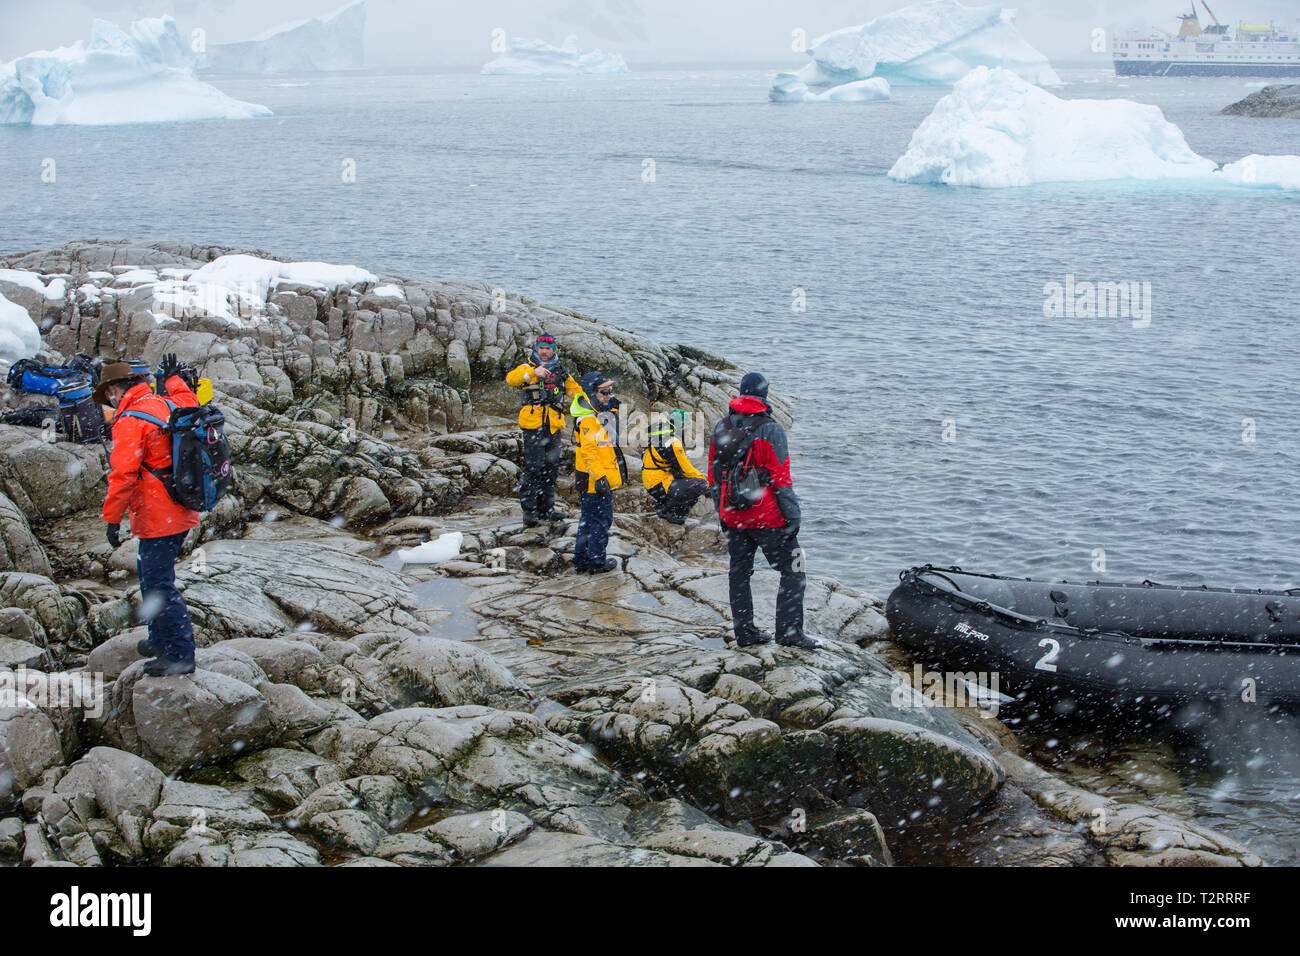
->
[[0, 0, 1300, 73]]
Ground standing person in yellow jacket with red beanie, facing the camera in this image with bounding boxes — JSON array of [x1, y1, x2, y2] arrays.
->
[[506, 332, 582, 528]]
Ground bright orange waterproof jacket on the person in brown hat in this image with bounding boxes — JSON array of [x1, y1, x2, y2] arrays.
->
[[103, 376, 200, 537]]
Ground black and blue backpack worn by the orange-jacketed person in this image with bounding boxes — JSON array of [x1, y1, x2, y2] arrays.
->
[[121, 395, 234, 511]]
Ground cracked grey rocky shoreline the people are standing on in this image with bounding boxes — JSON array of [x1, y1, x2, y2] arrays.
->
[[0, 242, 1260, 866]]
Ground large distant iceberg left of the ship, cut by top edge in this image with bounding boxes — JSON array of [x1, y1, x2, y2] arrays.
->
[[770, 0, 1061, 103]]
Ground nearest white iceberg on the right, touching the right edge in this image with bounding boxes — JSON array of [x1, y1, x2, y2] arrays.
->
[[889, 68, 1300, 189]]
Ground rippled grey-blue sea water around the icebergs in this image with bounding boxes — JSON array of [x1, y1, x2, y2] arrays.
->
[[0, 72, 1300, 858]]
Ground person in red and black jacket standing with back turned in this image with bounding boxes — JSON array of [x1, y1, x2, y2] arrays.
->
[[709, 372, 820, 649]]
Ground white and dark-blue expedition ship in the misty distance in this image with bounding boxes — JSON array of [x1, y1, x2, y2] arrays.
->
[[1115, 0, 1300, 77]]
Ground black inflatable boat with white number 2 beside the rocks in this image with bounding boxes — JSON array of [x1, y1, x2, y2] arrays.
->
[[885, 564, 1300, 710]]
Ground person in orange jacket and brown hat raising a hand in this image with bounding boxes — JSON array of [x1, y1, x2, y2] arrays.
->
[[94, 355, 200, 676]]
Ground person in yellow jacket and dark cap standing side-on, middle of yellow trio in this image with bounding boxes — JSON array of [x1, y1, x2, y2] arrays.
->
[[569, 372, 628, 575]]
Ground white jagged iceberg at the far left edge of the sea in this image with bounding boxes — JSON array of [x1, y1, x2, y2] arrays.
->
[[0, 17, 270, 126]]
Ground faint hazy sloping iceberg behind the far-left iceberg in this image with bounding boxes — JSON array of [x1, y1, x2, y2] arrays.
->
[[199, 0, 365, 73]]
